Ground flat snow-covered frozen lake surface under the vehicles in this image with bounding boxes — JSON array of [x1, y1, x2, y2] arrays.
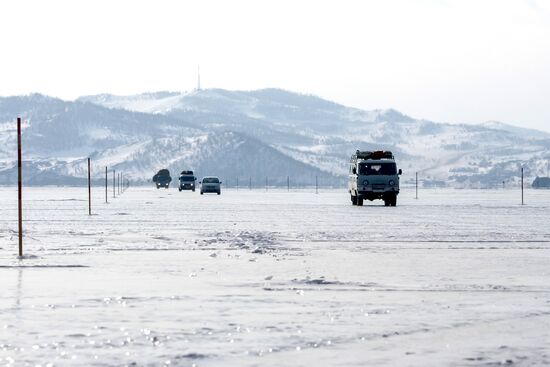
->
[[0, 187, 550, 366]]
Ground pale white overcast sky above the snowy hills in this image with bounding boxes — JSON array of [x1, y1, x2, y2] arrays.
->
[[0, 0, 550, 131]]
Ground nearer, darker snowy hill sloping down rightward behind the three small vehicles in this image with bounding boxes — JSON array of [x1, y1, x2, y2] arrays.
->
[[0, 95, 341, 185]]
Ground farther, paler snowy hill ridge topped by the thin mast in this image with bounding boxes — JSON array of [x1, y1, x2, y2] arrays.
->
[[77, 89, 550, 187]]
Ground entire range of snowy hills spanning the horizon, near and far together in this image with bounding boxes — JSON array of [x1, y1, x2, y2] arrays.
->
[[0, 89, 550, 187]]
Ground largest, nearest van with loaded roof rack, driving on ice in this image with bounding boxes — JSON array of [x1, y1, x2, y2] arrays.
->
[[348, 150, 402, 206]]
